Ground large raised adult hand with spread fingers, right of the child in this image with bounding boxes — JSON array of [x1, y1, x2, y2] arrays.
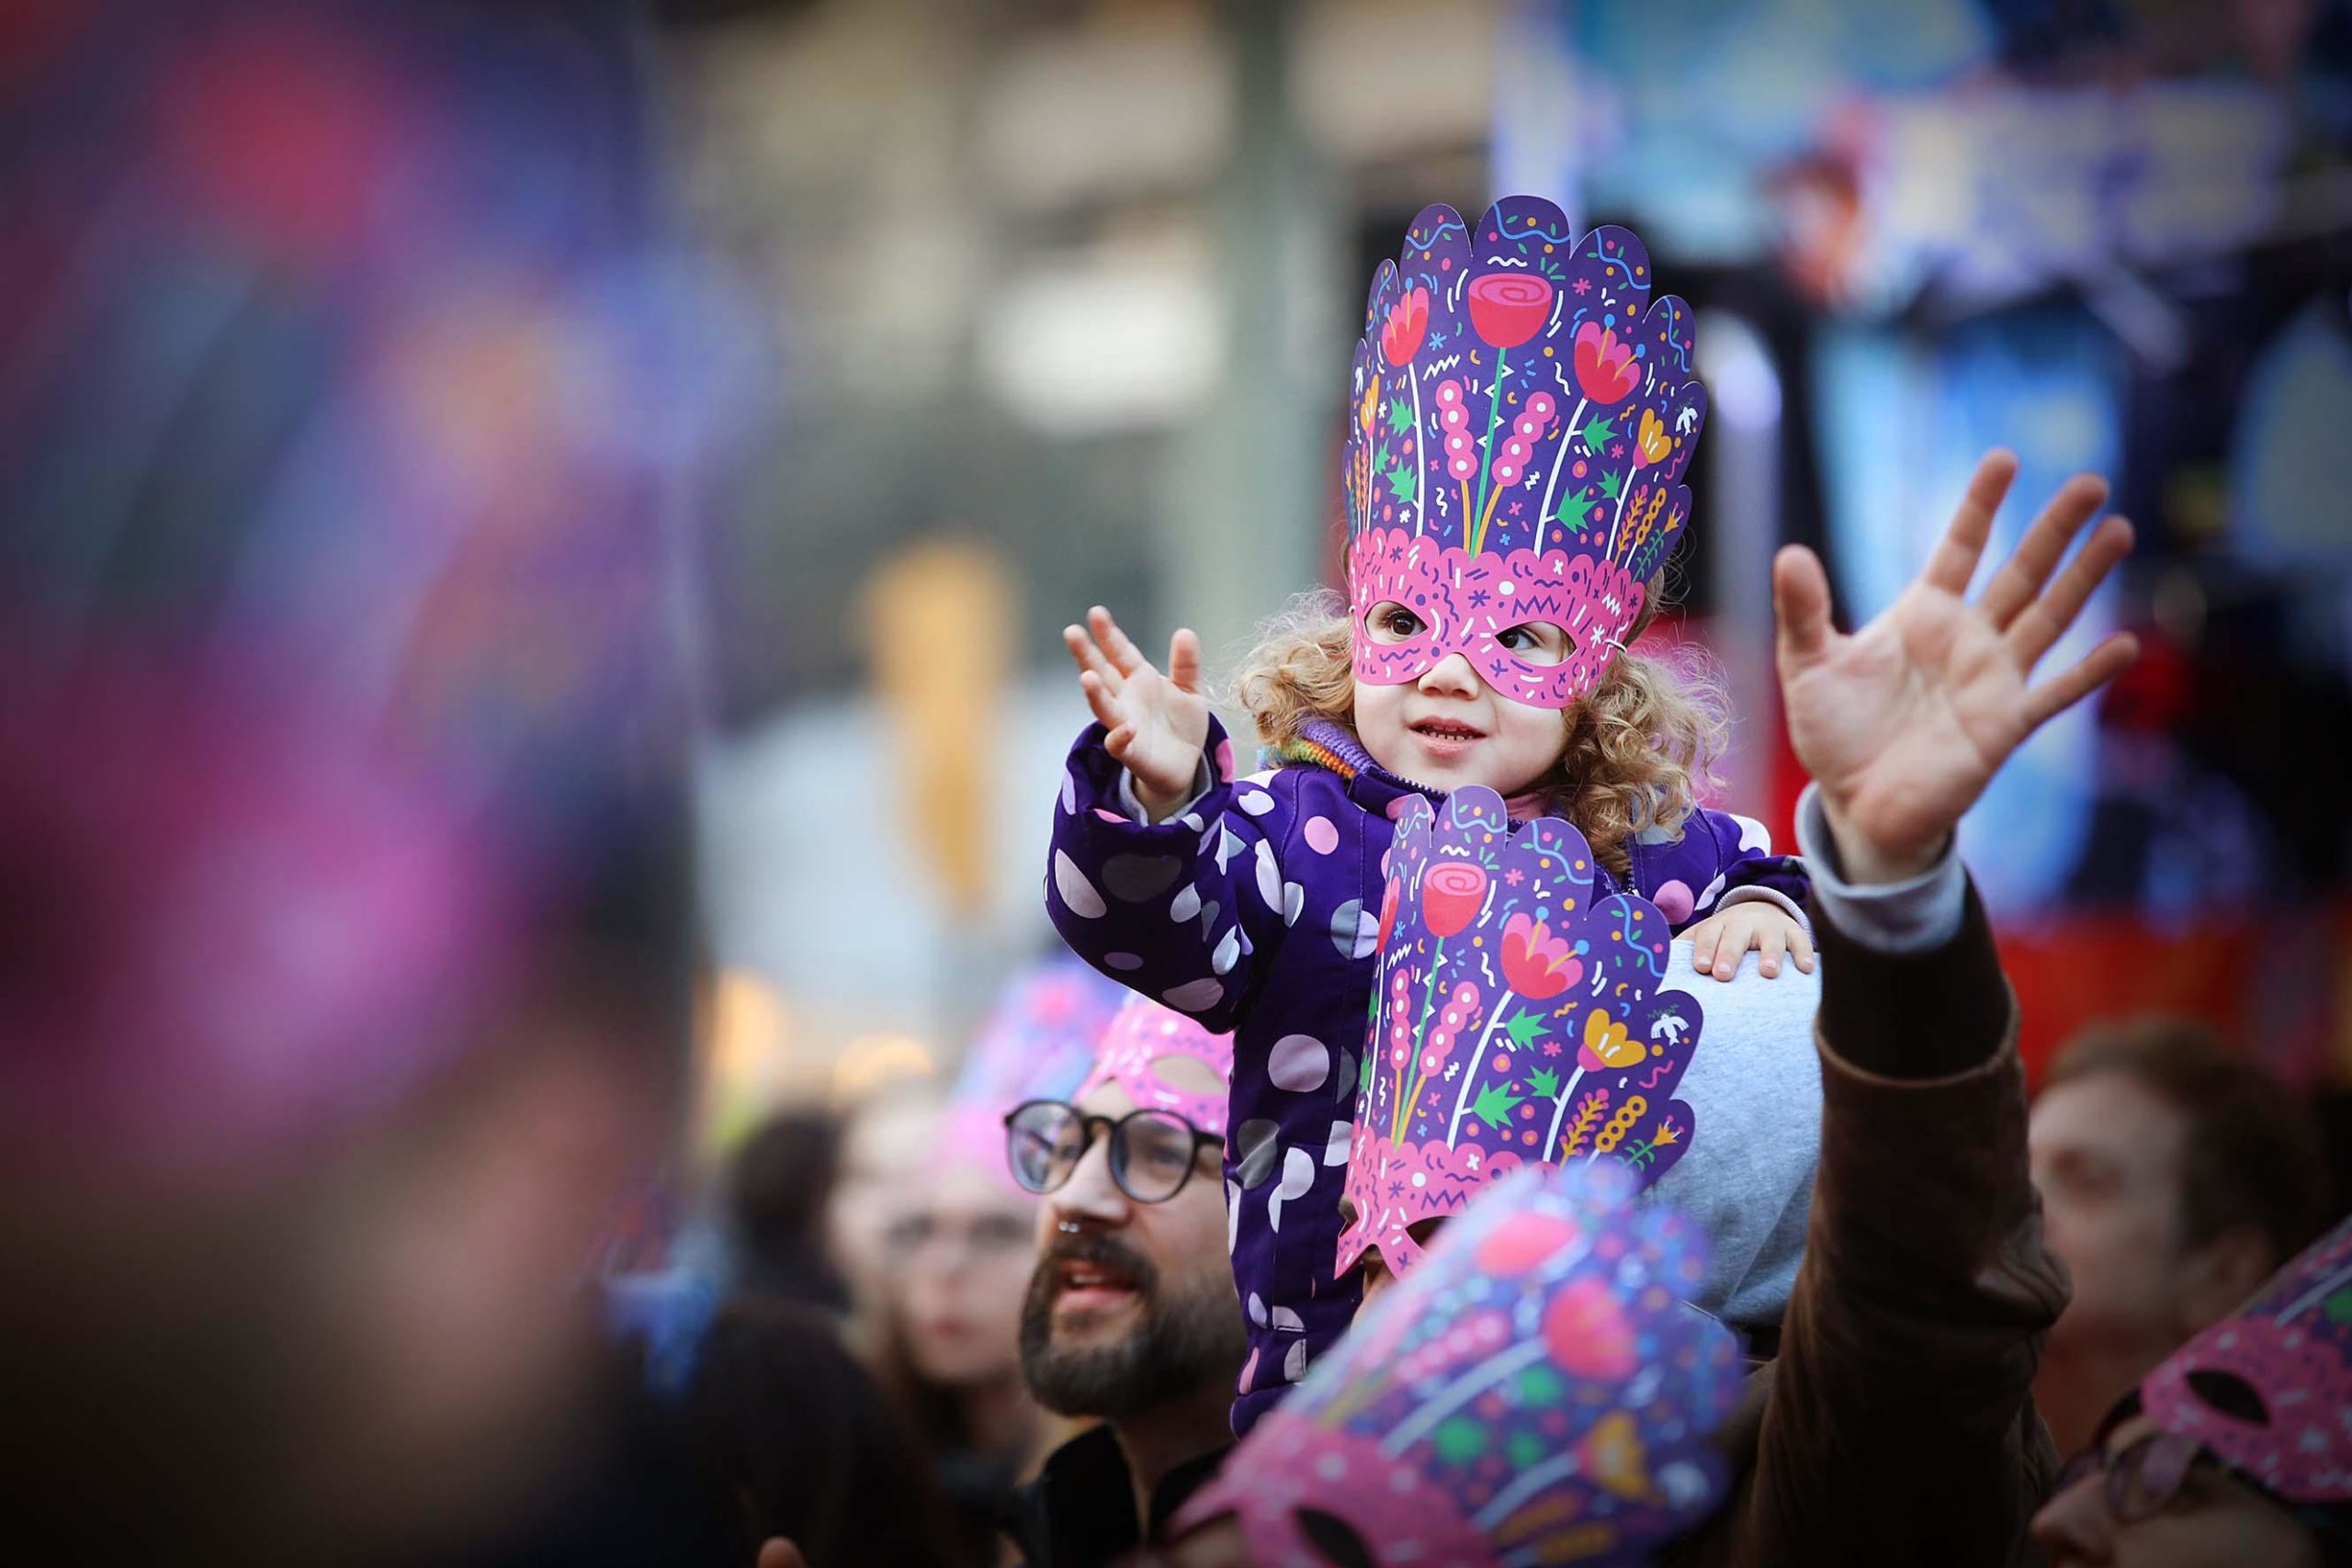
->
[[1773, 451, 2138, 882]]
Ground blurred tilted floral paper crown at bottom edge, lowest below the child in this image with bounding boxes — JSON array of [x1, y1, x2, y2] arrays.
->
[[1176, 1166, 1740, 1568]]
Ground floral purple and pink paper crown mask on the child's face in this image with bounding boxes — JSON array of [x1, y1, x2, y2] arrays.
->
[[1340, 195, 1708, 707]]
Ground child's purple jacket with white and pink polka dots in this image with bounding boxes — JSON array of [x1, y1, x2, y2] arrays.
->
[[1046, 719, 1806, 1432]]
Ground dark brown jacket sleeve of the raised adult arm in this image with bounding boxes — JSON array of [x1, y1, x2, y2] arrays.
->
[[1677, 888, 2067, 1568]]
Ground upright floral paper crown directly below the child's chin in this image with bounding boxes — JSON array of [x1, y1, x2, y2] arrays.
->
[[1339, 785, 1701, 1274]]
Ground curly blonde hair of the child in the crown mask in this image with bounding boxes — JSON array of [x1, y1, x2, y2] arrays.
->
[[1232, 579, 1731, 879]]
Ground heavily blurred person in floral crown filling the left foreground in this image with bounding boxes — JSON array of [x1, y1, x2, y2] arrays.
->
[[0, 0, 738, 1563]]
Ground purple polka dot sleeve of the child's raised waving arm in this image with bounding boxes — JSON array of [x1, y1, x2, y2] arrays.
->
[[1045, 719, 1301, 1032]]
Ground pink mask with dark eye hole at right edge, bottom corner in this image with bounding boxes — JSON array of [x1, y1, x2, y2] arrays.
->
[[2141, 1220, 2352, 1505]]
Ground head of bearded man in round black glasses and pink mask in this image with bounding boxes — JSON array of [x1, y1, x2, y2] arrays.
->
[[1007, 999, 1249, 1460]]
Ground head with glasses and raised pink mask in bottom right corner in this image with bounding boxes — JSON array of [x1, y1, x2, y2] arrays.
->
[[2032, 1223, 2352, 1568]]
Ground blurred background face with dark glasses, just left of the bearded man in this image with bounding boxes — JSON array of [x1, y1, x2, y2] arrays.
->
[[891, 1166, 1037, 1387]]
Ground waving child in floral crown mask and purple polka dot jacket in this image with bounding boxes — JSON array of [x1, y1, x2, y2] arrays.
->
[[1046, 197, 1811, 1432]]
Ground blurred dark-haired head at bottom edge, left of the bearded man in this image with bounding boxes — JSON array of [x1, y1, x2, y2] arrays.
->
[[682, 1295, 955, 1568]]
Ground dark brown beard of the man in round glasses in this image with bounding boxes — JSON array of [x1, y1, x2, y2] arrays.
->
[[1021, 1235, 1249, 1420]]
